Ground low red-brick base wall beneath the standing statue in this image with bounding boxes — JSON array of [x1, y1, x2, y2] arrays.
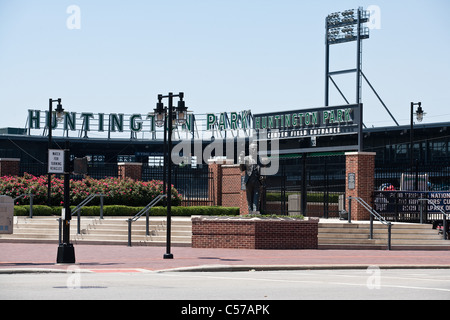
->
[[192, 217, 318, 249]]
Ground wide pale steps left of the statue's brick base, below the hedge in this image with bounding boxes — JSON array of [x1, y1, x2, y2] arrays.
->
[[0, 217, 192, 246]]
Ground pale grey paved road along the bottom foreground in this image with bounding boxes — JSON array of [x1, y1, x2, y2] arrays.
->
[[0, 267, 450, 306]]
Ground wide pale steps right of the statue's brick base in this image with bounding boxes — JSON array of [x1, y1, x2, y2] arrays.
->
[[319, 220, 450, 250]]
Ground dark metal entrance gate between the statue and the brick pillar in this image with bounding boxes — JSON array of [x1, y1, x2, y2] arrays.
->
[[262, 153, 345, 218]]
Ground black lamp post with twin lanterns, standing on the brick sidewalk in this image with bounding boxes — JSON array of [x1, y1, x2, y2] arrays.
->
[[154, 92, 187, 259]]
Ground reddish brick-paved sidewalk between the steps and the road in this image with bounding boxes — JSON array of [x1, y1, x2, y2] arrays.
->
[[0, 243, 450, 273]]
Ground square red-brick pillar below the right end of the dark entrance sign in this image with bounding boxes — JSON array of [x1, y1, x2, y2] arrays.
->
[[345, 152, 376, 221]]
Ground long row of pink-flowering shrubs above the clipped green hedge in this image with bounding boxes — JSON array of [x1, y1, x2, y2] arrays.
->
[[0, 173, 181, 206]]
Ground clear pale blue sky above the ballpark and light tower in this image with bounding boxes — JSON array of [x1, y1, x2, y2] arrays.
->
[[0, 0, 450, 127]]
